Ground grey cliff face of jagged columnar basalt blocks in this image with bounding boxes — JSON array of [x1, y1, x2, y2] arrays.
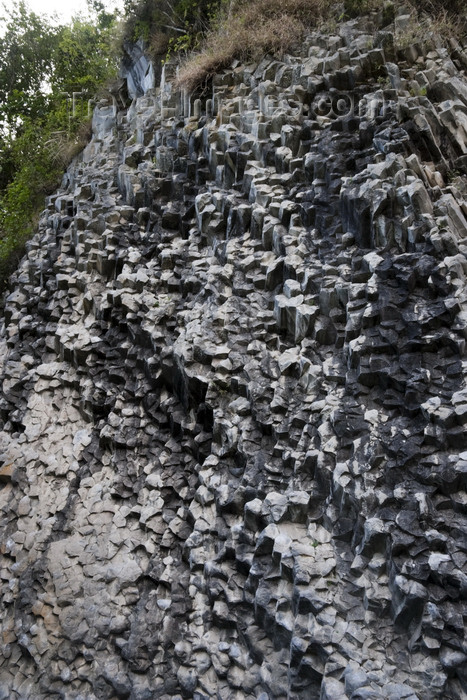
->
[[0, 9, 467, 700]]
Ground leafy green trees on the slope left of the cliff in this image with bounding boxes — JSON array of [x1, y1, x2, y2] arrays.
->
[[0, 0, 117, 288]]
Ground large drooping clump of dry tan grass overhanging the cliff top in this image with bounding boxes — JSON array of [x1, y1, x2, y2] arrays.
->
[[178, 0, 329, 90]]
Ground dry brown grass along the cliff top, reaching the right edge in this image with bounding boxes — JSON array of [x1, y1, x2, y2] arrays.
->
[[178, 0, 467, 90]]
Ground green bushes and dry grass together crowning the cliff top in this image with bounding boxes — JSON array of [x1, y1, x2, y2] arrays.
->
[[119, 0, 467, 90]]
